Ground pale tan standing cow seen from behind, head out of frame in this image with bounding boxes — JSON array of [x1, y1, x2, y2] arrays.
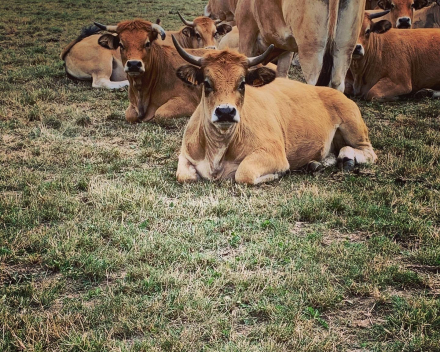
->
[[235, 0, 365, 92]]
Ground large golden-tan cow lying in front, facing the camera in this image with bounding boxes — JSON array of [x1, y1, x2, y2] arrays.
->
[[174, 41, 376, 184]]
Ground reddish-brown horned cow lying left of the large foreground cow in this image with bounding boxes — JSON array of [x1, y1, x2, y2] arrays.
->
[[95, 19, 213, 123]]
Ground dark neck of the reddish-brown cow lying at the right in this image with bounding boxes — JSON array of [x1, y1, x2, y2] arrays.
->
[[351, 33, 382, 95]]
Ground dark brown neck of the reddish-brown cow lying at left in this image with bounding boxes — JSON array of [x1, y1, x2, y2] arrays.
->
[[129, 42, 173, 118]]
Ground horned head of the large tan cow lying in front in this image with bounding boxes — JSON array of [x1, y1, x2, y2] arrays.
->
[[173, 36, 276, 132]]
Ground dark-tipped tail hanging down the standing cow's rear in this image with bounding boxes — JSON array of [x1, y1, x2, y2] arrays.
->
[[316, 0, 339, 87]]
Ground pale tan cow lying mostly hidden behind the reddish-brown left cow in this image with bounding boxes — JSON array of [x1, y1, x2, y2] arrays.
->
[[61, 13, 231, 89]]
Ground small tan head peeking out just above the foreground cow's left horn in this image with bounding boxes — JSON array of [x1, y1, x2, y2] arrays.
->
[[177, 12, 232, 49]]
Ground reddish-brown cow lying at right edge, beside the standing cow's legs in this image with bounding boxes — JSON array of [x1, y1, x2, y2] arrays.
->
[[350, 14, 440, 101]]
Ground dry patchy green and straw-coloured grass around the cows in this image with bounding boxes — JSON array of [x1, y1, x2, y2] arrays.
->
[[0, 0, 440, 352]]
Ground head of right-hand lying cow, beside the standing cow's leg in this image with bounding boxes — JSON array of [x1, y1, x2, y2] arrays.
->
[[352, 10, 393, 60]]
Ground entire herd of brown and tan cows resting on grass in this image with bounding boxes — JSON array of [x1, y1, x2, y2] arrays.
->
[[61, 0, 440, 184]]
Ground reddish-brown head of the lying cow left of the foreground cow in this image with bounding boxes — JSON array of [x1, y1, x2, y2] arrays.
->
[[95, 20, 166, 76]]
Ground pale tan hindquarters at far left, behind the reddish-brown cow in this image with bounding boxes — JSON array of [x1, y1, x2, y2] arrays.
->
[[60, 26, 128, 89]]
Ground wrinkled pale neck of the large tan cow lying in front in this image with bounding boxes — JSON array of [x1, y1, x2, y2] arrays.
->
[[202, 98, 240, 178]]
